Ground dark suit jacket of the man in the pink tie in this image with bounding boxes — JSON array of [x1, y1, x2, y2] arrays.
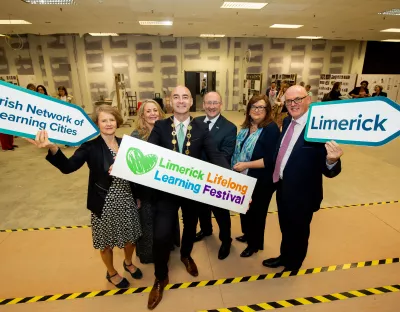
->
[[275, 117, 341, 211]]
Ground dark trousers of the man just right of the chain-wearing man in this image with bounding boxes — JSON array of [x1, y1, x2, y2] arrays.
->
[[198, 204, 232, 244]]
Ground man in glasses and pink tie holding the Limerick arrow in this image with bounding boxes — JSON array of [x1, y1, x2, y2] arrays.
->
[[263, 86, 343, 271]]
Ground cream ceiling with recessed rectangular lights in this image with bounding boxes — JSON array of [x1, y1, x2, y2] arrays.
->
[[0, 0, 400, 40]]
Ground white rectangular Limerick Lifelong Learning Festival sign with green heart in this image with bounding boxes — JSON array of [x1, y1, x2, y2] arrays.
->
[[111, 135, 257, 213]]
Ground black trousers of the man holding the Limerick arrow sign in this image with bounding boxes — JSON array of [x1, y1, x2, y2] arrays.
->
[[276, 182, 313, 270]]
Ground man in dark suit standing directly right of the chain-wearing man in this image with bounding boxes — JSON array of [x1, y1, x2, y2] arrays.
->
[[196, 91, 237, 260]]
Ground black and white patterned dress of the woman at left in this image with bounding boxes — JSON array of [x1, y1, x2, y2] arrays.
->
[[92, 149, 142, 250]]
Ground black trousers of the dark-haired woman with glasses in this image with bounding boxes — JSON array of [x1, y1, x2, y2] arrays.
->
[[240, 182, 275, 250]]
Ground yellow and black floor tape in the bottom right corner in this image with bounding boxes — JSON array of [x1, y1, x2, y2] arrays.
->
[[198, 284, 400, 312]]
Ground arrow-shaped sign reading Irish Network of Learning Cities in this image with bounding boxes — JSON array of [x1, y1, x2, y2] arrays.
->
[[0, 81, 99, 145]]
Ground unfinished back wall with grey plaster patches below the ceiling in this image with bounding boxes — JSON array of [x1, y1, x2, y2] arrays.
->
[[0, 35, 366, 112]]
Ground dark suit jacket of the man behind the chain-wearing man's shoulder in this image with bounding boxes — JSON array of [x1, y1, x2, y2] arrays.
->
[[195, 115, 237, 164]]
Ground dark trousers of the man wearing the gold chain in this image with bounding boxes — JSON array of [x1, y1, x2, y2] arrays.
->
[[153, 193, 198, 280]]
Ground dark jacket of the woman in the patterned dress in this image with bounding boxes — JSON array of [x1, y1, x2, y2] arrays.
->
[[46, 136, 133, 218]]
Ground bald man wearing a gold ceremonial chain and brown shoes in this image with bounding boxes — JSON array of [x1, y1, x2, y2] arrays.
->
[[147, 86, 230, 310]]
